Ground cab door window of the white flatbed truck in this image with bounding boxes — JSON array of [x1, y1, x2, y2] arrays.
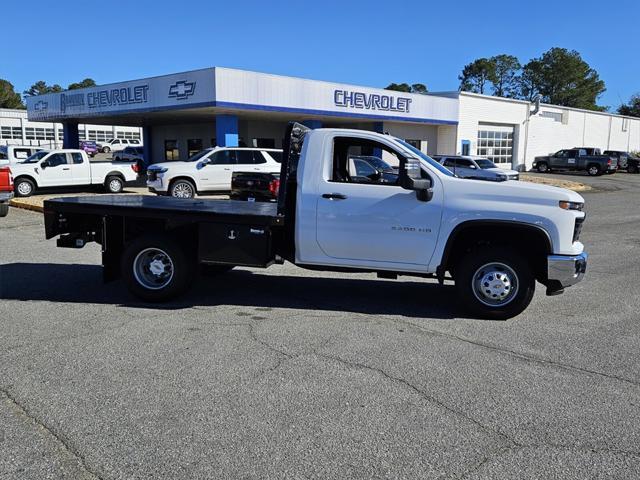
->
[[331, 137, 401, 185]]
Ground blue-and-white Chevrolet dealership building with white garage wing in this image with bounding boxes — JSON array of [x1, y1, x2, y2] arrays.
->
[[5, 67, 640, 170]]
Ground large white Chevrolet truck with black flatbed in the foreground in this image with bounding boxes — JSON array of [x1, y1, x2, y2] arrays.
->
[[44, 123, 587, 319]]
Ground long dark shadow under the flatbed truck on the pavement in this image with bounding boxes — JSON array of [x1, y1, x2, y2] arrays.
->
[[0, 263, 458, 319]]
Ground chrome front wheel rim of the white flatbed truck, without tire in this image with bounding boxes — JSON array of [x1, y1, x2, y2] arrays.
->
[[471, 262, 518, 307]]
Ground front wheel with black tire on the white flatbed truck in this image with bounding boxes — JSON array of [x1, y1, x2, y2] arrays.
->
[[455, 246, 536, 320]]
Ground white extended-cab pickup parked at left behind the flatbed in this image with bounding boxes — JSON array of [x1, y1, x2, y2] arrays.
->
[[11, 149, 138, 197]]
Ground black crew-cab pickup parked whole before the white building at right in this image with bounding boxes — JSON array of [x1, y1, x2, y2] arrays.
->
[[533, 148, 618, 176]]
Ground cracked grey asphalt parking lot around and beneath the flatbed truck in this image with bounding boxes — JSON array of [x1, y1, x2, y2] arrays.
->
[[0, 173, 640, 479]]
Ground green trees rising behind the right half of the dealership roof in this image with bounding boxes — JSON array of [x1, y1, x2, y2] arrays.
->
[[385, 47, 640, 117]]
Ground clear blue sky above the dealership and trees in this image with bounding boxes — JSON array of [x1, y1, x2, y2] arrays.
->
[[5, 0, 640, 108]]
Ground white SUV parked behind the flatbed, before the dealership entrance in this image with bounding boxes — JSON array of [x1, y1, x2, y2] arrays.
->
[[147, 147, 282, 198]]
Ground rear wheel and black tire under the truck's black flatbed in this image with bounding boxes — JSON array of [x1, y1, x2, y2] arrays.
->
[[121, 235, 195, 302]]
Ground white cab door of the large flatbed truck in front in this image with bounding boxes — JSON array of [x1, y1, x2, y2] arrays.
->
[[316, 137, 442, 268]]
